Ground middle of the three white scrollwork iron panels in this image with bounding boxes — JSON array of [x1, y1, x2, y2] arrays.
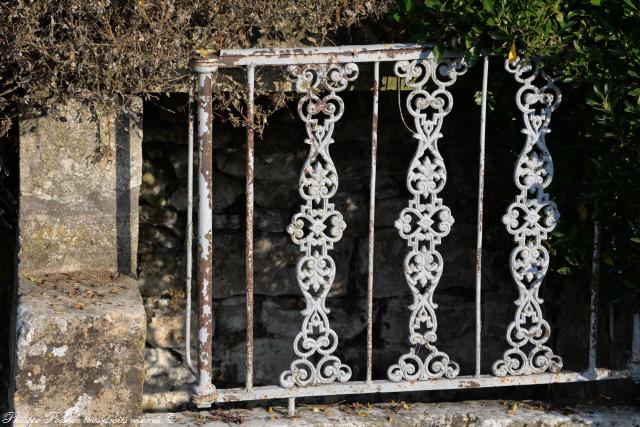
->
[[387, 59, 467, 381]]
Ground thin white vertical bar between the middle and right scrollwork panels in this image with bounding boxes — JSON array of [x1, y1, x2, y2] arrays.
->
[[476, 55, 489, 377]]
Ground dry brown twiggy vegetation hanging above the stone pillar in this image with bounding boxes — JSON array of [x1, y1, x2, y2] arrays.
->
[[0, 0, 392, 135]]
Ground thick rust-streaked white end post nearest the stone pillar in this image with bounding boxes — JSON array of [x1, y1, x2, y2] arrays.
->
[[195, 71, 215, 396]]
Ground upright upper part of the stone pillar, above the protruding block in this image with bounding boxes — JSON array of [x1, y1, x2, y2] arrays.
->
[[19, 98, 142, 274]]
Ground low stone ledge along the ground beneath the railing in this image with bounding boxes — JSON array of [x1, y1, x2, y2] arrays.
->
[[143, 401, 640, 427]]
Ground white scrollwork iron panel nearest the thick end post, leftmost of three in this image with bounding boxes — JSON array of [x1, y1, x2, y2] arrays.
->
[[280, 63, 358, 387]]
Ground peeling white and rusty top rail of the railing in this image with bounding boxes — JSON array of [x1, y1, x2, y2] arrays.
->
[[192, 43, 463, 72]]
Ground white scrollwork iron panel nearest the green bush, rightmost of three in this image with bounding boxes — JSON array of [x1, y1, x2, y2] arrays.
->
[[493, 58, 562, 376]]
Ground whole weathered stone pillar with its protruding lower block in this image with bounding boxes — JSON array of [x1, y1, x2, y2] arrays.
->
[[12, 98, 146, 424]]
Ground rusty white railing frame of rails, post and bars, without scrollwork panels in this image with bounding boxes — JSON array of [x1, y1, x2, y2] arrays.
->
[[187, 44, 640, 415]]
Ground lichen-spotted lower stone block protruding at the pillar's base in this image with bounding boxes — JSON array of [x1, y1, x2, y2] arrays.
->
[[13, 273, 146, 424]]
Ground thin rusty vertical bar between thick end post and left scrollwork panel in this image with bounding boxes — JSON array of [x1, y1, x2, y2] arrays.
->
[[246, 65, 255, 390]]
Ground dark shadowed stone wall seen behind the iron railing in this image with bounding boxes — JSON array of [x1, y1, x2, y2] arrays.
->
[[138, 83, 632, 404]]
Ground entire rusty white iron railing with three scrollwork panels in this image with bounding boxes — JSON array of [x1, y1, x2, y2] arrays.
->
[[186, 44, 640, 413]]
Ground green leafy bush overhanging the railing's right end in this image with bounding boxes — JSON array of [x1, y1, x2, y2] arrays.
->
[[392, 0, 640, 303]]
